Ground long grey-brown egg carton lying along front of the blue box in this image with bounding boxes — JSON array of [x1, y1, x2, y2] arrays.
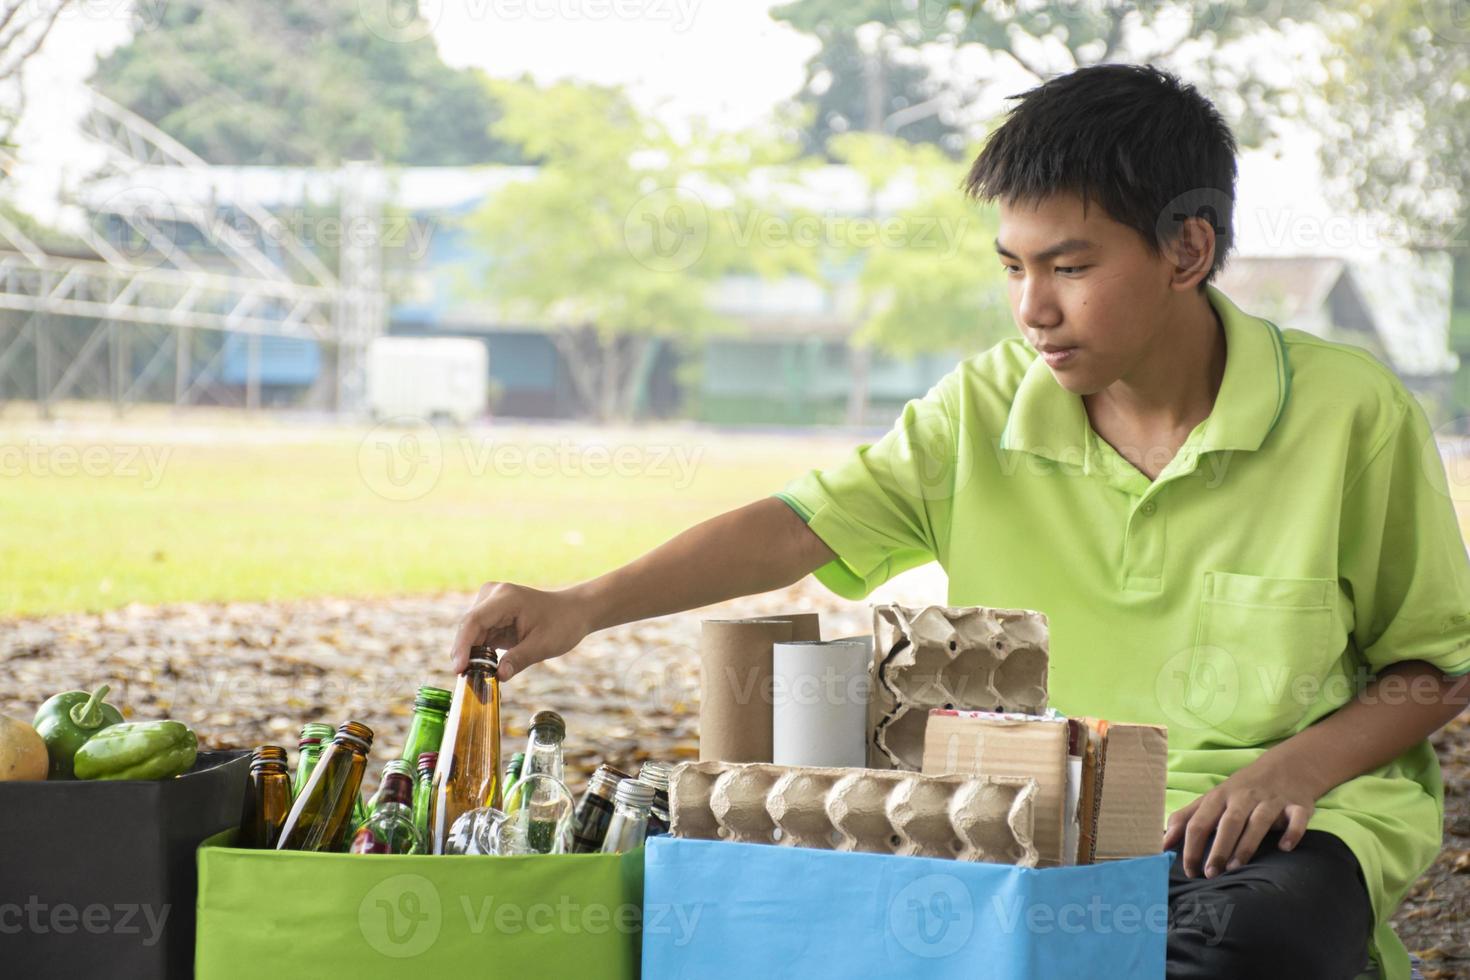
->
[[669, 763, 1038, 867]]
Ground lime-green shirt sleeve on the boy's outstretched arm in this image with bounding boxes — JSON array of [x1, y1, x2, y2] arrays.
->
[[776, 369, 958, 599]]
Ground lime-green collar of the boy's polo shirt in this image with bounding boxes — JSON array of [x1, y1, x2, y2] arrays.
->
[[1000, 285, 1291, 466]]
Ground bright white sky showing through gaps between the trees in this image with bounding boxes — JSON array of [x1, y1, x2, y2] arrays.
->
[[2, 0, 1385, 254]]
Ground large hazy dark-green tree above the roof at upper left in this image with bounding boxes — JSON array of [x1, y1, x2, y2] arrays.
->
[[91, 0, 519, 166]]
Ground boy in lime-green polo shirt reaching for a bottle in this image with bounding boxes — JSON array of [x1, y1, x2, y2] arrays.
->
[[454, 65, 1470, 977]]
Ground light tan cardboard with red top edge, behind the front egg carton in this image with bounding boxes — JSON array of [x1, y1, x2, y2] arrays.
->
[[923, 708, 1076, 868]]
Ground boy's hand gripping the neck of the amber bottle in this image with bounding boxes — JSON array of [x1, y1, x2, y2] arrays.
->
[[450, 582, 589, 680]]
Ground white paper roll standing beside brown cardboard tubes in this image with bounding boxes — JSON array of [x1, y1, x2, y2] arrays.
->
[[772, 636, 873, 767]]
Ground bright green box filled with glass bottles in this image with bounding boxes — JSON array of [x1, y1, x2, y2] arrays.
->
[[194, 835, 644, 980]]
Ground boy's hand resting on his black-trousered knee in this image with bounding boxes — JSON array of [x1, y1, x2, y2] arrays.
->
[[1164, 755, 1317, 877]]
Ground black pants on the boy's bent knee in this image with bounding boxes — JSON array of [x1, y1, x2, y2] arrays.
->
[[1167, 830, 1373, 980]]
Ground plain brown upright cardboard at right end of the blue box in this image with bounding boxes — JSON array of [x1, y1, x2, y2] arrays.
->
[[1080, 718, 1169, 861]]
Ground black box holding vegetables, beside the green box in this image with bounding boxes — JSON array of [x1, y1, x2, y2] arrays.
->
[[0, 751, 250, 980]]
